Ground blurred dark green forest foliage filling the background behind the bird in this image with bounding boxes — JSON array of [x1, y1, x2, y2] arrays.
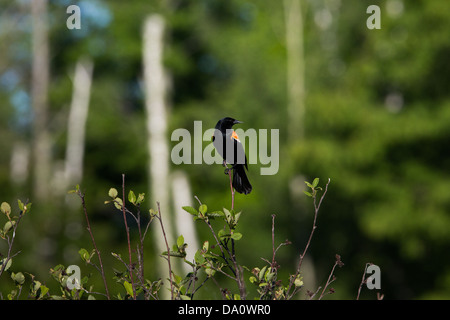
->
[[0, 0, 450, 299]]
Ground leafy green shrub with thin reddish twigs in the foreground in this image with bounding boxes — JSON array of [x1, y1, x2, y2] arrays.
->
[[0, 175, 356, 300]]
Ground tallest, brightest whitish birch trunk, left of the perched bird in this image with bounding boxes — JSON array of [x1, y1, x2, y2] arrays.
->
[[143, 14, 174, 298]]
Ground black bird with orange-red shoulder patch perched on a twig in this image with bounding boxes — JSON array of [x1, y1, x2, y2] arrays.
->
[[212, 117, 252, 194]]
